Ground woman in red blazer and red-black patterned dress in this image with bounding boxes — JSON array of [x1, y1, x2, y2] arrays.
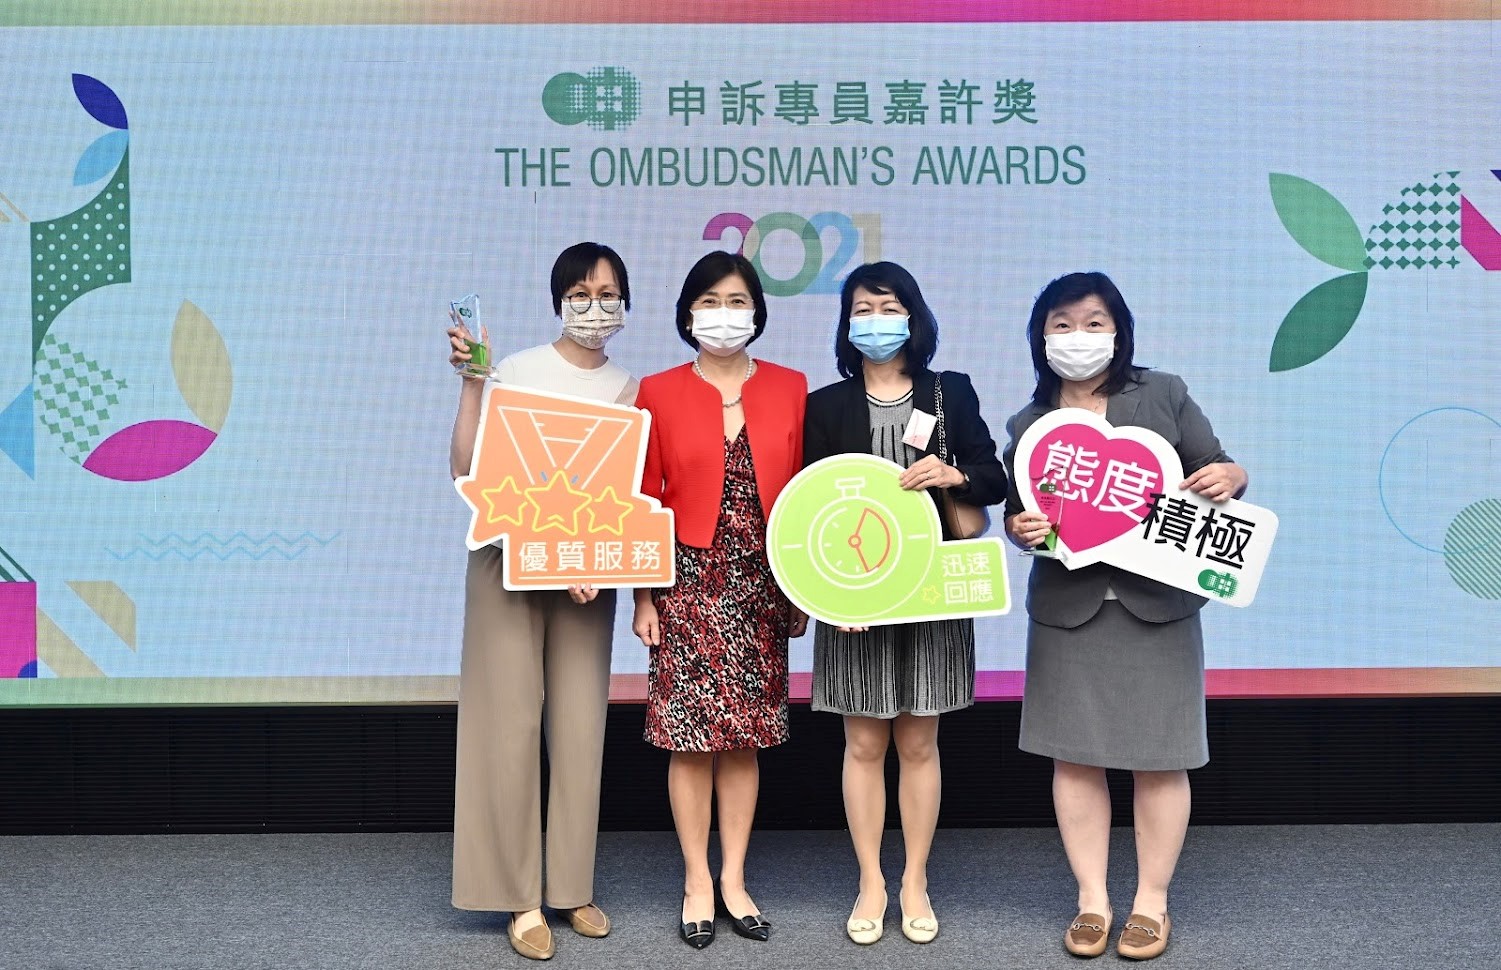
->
[[633, 252, 808, 949]]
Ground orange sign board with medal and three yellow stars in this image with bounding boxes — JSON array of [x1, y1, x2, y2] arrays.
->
[[453, 384, 674, 590]]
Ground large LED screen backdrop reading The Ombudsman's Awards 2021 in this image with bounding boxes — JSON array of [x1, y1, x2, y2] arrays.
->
[[0, 2, 1501, 704]]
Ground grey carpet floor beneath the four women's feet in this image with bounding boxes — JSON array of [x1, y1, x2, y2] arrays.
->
[[0, 824, 1501, 970]]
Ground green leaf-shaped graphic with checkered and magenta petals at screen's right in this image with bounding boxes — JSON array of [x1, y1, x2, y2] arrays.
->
[[1268, 170, 1501, 372]]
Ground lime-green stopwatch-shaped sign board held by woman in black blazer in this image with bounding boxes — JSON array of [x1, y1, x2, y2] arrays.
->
[[767, 455, 1010, 626]]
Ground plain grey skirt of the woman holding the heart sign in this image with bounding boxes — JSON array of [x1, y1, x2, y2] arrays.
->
[[1019, 599, 1210, 772]]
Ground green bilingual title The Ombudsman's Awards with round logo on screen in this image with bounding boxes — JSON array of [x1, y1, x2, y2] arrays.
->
[[494, 65, 1088, 189]]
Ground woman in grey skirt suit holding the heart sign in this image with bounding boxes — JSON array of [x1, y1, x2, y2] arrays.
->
[[1004, 273, 1246, 959]]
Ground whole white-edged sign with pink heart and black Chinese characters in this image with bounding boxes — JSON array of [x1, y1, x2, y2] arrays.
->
[[1012, 407, 1277, 607]]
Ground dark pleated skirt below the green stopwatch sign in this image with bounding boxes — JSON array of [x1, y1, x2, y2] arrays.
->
[[812, 620, 974, 718]]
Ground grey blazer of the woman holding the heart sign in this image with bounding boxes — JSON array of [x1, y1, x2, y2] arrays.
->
[[1001, 371, 1238, 629]]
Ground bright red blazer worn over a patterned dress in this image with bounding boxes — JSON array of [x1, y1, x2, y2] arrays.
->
[[636, 360, 808, 550]]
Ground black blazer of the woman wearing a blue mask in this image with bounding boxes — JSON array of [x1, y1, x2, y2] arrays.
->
[[803, 369, 1009, 539]]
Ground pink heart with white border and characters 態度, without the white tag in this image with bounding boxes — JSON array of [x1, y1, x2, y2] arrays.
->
[[1015, 408, 1183, 569]]
